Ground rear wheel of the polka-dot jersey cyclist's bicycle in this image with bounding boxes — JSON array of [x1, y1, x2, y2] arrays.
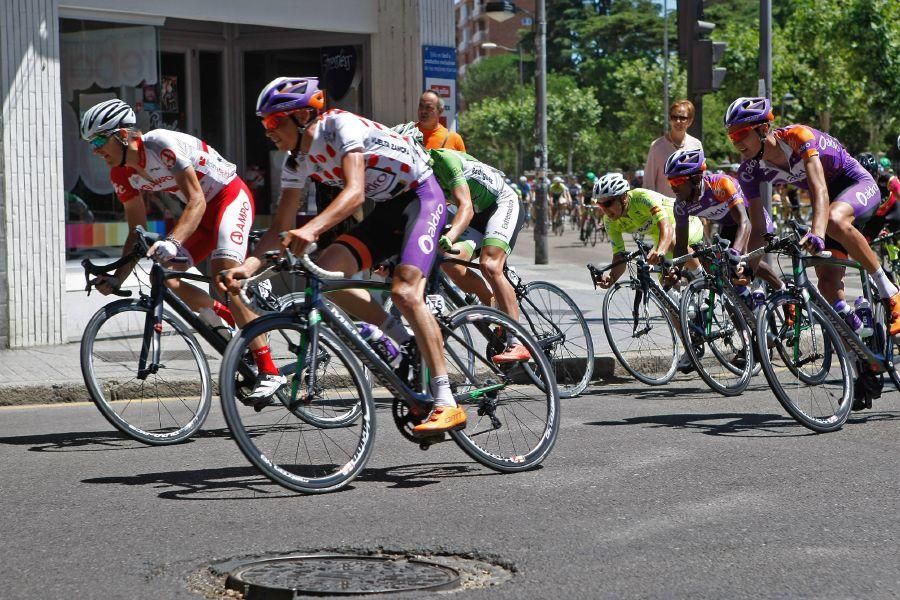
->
[[442, 306, 559, 473]]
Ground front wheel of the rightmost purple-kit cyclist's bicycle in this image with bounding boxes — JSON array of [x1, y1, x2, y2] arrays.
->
[[756, 292, 853, 432]]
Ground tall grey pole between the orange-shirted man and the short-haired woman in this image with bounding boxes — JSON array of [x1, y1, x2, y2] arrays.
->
[[534, 0, 550, 265]]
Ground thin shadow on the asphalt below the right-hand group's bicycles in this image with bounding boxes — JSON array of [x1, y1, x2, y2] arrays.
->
[[585, 412, 816, 437]]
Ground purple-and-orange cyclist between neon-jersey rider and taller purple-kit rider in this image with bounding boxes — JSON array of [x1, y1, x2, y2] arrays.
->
[[664, 149, 784, 307]]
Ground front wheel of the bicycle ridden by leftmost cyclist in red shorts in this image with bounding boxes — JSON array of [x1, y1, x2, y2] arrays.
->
[[81, 300, 212, 446]]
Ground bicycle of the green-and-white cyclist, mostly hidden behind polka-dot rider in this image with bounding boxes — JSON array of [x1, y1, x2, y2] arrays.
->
[[385, 256, 594, 398]]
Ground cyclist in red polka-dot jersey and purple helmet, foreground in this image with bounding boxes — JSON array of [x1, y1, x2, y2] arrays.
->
[[228, 77, 466, 435]]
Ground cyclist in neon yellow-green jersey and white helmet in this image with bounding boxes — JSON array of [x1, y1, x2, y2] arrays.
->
[[593, 173, 703, 289]]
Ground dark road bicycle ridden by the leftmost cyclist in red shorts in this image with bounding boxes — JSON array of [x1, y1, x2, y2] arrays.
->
[[81, 227, 256, 445]]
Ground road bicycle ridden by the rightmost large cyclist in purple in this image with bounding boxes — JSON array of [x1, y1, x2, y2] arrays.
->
[[748, 221, 900, 432]]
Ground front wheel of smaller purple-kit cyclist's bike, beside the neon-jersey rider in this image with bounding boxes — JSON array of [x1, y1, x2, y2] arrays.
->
[[680, 279, 754, 396]]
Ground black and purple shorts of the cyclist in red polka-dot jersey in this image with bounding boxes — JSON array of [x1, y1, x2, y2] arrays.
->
[[334, 175, 447, 276]]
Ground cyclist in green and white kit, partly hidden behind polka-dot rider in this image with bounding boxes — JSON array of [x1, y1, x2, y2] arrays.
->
[[429, 148, 531, 362]]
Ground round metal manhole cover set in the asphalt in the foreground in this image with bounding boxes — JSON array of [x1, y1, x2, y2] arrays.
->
[[203, 549, 513, 600]]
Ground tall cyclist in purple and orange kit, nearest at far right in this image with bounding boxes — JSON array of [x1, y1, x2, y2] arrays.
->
[[724, 98, 900, 335]]
